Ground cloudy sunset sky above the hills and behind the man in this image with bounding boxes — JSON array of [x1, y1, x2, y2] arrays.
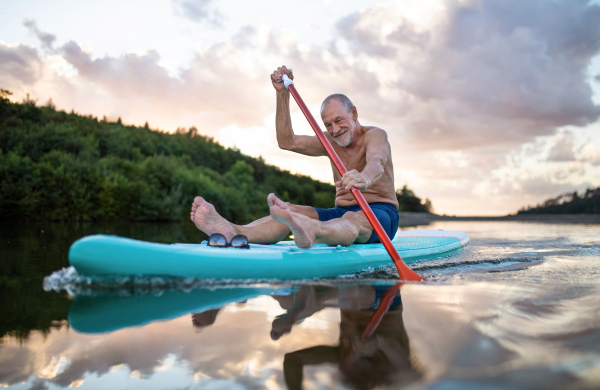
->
[[0, 0, 600, 215]]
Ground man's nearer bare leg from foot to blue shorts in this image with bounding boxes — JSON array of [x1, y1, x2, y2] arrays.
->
[[268, 194, 373, 248]]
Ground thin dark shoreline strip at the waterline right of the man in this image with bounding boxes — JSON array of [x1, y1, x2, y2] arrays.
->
[[400, 211, 600, 227]]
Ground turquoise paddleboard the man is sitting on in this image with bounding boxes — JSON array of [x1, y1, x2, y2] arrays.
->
[[69, 230, 469, 280]]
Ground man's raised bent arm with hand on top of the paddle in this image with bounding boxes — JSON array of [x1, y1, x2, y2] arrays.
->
[[271, 66, 327, 156]]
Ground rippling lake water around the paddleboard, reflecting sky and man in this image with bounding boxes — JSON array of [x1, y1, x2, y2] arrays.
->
[[0, 222, 600, 390]]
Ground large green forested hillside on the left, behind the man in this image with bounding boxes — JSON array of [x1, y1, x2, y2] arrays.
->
[[0, 90, 335, 223]]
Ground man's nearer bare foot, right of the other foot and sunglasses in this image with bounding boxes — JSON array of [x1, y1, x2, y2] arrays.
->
[[267, 194, 317, 248]]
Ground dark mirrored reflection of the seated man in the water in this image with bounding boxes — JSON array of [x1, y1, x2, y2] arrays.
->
[[192, 284, 420, 389]]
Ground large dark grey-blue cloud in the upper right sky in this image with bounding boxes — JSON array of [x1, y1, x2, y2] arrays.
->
[[378, 1, 600, 149]]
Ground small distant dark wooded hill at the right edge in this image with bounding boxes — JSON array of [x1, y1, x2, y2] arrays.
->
[[517, 187, 600, 214]]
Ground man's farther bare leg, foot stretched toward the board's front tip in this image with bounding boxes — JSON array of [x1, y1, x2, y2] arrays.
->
[[190, 194, 319, 244]]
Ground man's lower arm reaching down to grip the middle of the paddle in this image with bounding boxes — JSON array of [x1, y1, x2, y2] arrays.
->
[[335, 128, 391, 191]]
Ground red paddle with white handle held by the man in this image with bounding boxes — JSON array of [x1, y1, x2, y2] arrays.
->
[[278, 69, 423, 282]]
